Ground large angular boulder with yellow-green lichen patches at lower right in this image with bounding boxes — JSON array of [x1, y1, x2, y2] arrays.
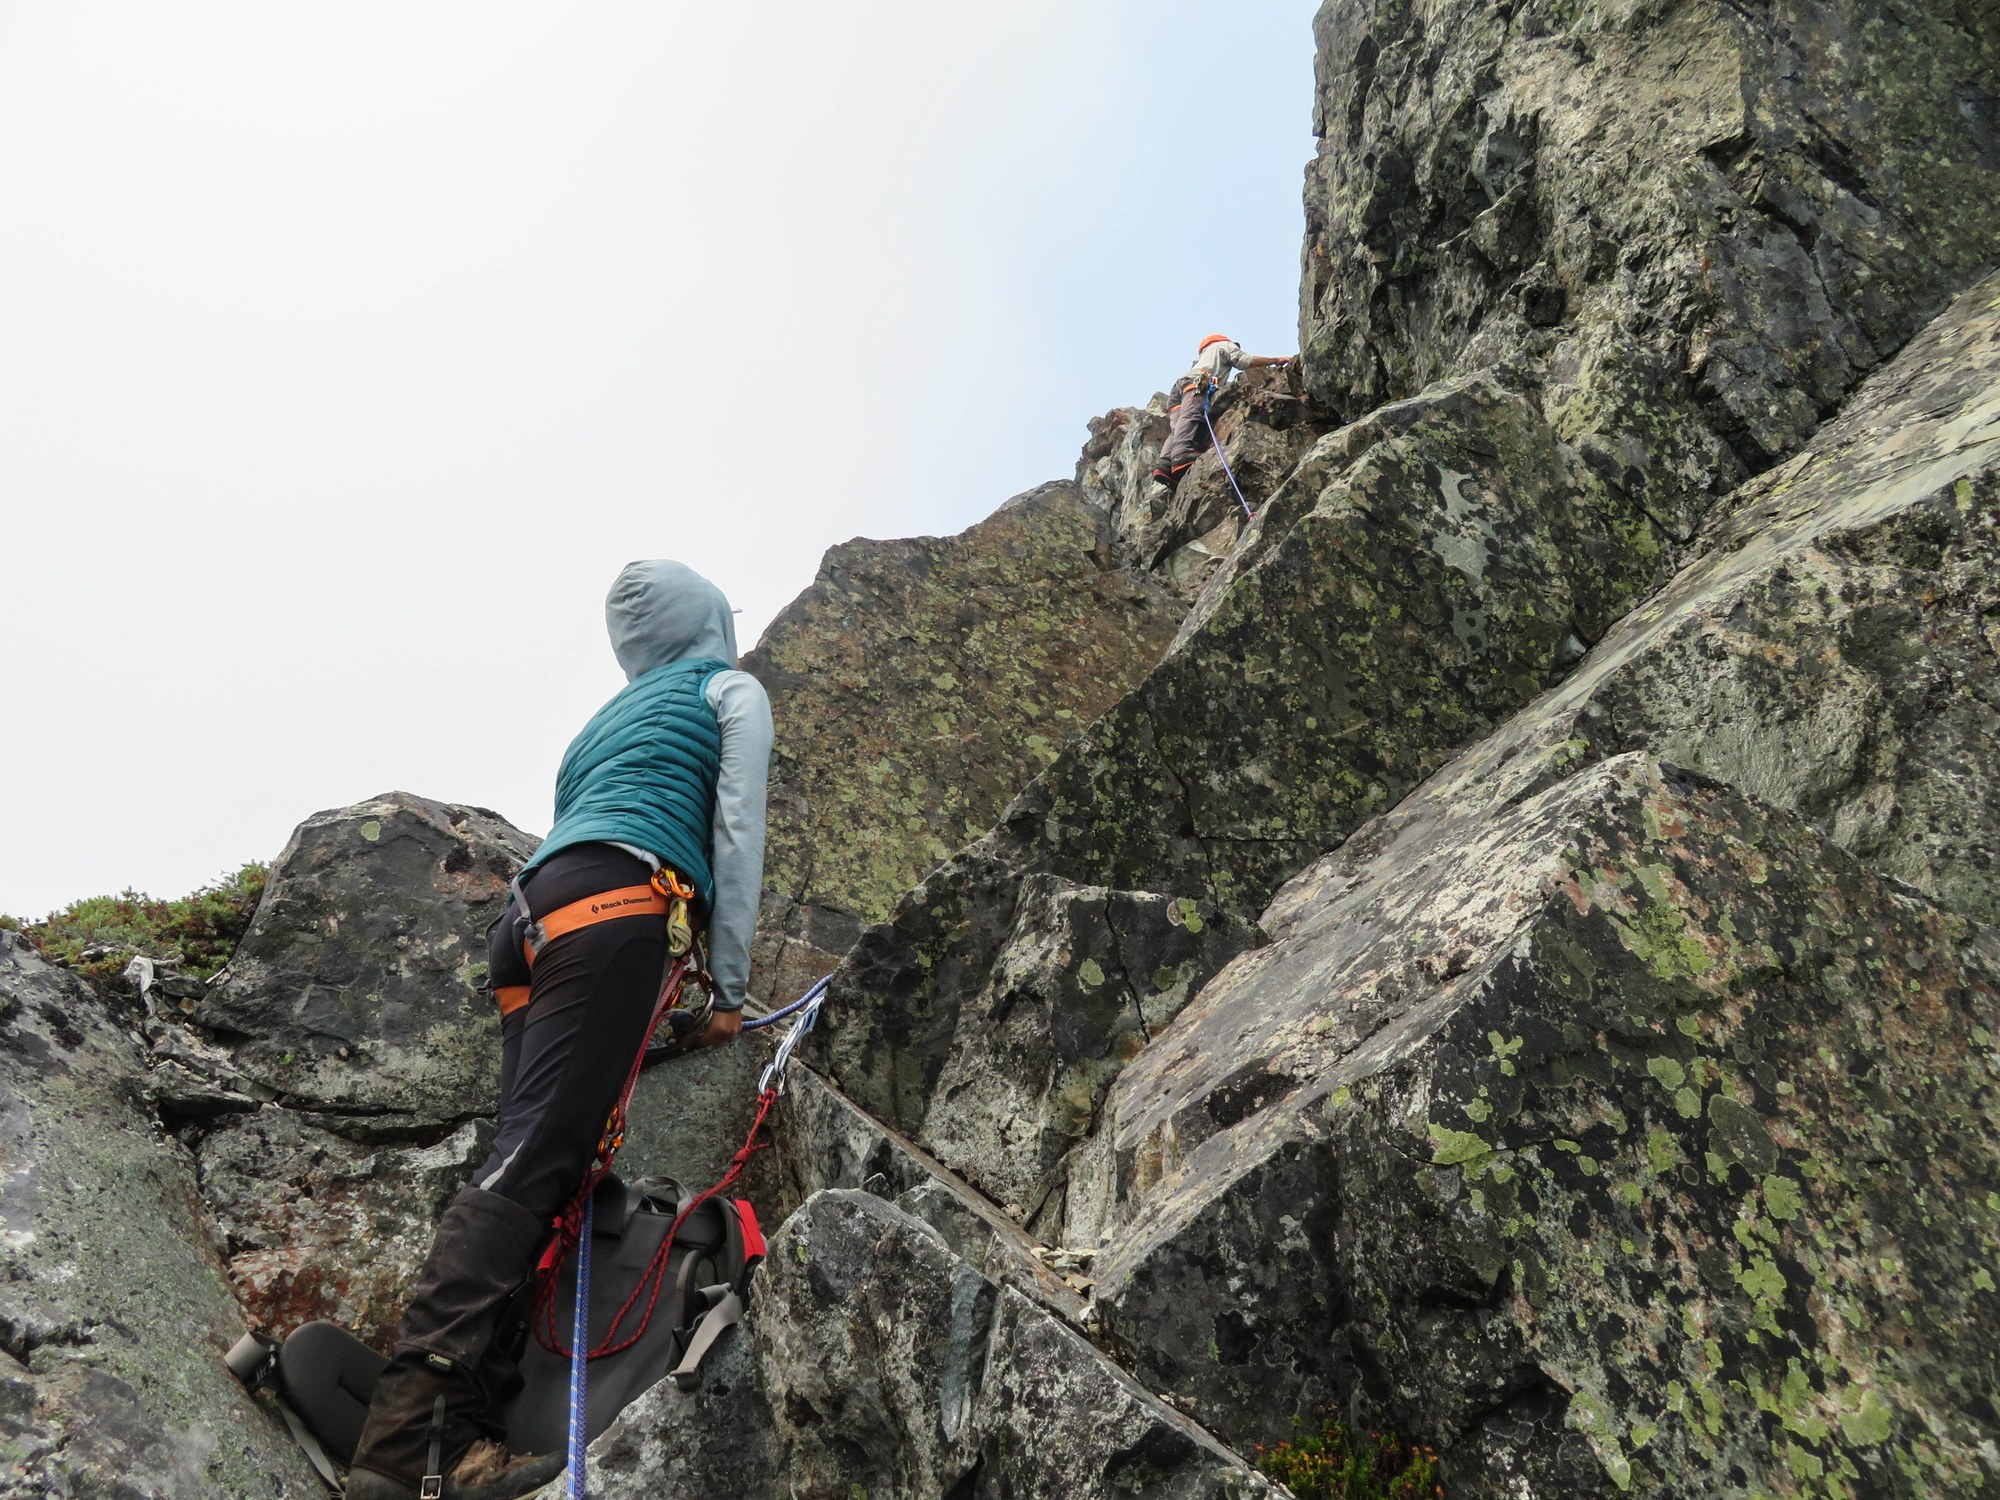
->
[[1100, 754, 2000, 1496]]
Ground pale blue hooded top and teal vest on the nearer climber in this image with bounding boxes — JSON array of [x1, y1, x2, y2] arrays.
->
[[526, 562, 772, 1010]]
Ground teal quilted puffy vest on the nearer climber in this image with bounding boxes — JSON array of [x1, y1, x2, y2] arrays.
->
[[522, 660, 730, 912]]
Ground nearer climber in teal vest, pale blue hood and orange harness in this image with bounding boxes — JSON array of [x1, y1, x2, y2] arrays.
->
[[346, 562, 772, 1500]]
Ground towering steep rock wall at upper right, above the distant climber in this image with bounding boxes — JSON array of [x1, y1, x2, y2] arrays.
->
[[1300, 0, 2000, 530]]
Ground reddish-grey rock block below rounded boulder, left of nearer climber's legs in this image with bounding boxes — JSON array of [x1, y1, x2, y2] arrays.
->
[[196, 1104, 492, 1352]]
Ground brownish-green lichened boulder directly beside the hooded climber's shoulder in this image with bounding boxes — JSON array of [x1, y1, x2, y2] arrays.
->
[[744, 484, 1182, 928]]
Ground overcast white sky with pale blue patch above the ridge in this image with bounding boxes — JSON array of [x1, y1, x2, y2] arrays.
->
[[0, 0, 1314, 916]]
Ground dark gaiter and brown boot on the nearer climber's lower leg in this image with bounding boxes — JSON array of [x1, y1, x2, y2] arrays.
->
[[346, 1188, 564, 1500]]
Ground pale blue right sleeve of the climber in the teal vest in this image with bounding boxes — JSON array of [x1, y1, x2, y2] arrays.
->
[[706, 672, 772, 1010]]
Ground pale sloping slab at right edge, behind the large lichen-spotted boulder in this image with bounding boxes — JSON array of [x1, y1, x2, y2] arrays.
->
[[1390, 266, 2000, 936]]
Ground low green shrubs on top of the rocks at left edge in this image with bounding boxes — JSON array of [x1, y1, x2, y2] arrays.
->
[[0, 862, 270, 980]]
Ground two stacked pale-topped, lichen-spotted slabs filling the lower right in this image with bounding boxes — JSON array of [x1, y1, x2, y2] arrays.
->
[[1076, 268, 2000, 1496]]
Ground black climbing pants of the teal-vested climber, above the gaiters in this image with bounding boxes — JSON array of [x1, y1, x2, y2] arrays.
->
[[472, 844, 666, 1218]]
